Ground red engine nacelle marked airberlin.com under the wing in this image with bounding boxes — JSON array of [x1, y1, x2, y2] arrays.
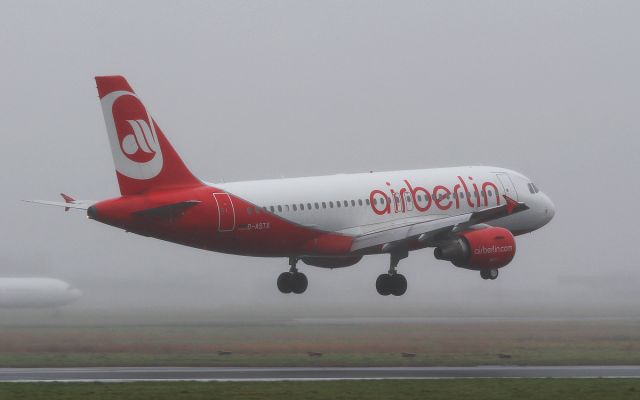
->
[[434, 228, 516, 269]]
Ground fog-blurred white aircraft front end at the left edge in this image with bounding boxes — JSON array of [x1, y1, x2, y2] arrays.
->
[[0, 278, 82, 308]]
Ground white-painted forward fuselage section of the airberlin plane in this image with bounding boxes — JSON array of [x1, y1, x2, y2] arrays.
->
[[215, 167, 555, 235]]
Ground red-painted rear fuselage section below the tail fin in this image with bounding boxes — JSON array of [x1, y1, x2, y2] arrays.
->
[[94, 186, 352, 256]]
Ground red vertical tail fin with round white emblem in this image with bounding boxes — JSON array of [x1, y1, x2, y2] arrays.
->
[[96, 76, 201, 196]]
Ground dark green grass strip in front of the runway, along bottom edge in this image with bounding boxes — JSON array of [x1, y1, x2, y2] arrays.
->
[[0, 379, 640, 400]]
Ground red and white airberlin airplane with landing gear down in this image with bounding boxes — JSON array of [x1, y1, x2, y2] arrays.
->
[[31, 76, 555, 296]]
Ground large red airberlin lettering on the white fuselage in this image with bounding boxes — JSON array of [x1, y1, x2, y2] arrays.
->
[[369, 176, 500, 215]]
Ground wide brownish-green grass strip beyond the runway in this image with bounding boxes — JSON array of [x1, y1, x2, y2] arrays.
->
[[0, 320, 640, 367]]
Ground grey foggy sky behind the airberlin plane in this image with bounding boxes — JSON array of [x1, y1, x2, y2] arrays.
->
[[0, 1, 640, 313]]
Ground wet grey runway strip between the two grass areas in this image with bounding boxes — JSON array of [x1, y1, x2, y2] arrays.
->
[[0, 365, 640, 382]]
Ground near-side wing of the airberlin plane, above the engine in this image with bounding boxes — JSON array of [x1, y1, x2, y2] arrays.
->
[[351, 195, 529, 251]]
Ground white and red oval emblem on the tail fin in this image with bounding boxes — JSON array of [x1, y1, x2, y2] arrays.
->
[[101, 90, 163, 180]]
